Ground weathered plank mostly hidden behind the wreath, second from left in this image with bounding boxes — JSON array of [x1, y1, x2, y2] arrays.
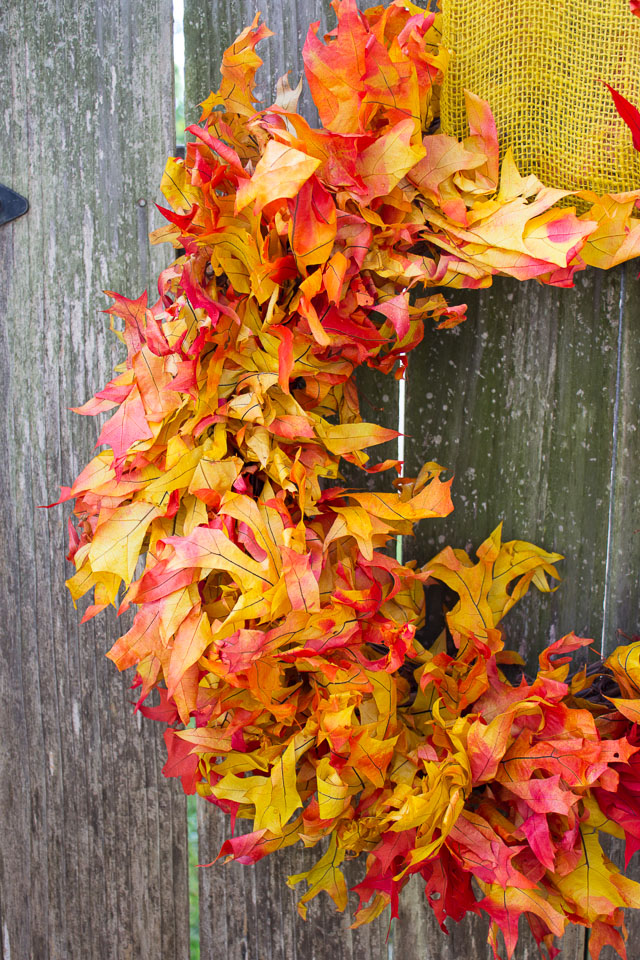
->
[[184, 0, 397, 960]]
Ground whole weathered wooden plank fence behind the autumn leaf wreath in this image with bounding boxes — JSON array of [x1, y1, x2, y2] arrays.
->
[[0, 0, 640, 960]]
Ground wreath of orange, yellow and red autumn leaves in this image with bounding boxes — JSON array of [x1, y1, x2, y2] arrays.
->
[[55, 0, 640, 958]]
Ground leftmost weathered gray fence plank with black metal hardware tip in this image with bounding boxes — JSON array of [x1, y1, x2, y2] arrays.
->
[[0, 0, 188, 960]]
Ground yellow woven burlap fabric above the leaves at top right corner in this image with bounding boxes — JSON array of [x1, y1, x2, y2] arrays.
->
[[441, 0, 640, 193]]
